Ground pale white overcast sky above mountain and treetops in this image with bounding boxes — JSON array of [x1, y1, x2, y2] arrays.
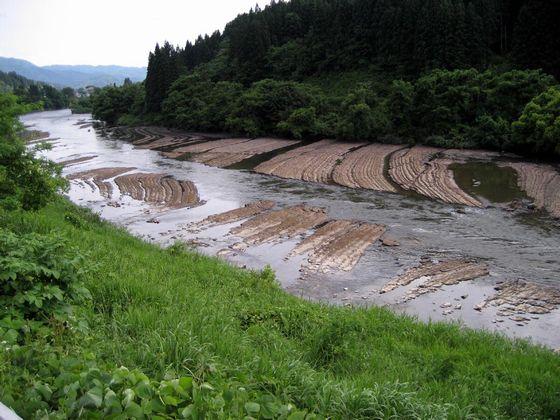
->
[[0, 0, 270, 66]]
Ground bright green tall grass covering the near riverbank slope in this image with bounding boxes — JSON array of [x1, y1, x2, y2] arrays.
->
[[4, 201, 560, 418]]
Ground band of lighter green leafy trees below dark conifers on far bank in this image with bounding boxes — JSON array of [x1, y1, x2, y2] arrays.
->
[[114, 69, 555, 155]]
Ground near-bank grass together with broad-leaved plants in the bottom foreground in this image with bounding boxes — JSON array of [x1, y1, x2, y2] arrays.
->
[[0, 200, 560, 418]]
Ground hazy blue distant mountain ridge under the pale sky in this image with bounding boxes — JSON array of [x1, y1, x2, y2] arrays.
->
[[0, 57, 146, 88]]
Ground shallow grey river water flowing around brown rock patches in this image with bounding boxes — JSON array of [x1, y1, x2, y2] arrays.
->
[[22, 110, 560, 348]]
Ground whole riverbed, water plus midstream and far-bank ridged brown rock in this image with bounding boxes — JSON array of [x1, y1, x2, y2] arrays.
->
[[23, 111, 560, 348]]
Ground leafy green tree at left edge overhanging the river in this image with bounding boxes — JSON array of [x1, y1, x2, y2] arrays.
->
[[0, 94, 67, 209]]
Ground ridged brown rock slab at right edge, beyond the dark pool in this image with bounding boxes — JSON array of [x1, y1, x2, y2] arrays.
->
[[507, 162, 560, 218]]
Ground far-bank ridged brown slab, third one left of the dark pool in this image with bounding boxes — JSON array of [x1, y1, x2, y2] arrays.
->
[[255, 140, 365, 183]]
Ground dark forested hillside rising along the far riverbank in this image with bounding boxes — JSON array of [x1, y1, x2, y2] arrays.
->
[[93, 0, 560, 156]]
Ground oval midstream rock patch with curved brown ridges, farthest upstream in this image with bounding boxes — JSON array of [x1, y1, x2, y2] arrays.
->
[[115, 173, 202, 208]]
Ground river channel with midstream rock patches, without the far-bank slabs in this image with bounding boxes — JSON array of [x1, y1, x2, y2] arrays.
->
[[24, 108, 560, 349]]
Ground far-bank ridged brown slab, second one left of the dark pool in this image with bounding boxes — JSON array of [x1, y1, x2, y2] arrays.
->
[[332, 144, 403, 193]]
